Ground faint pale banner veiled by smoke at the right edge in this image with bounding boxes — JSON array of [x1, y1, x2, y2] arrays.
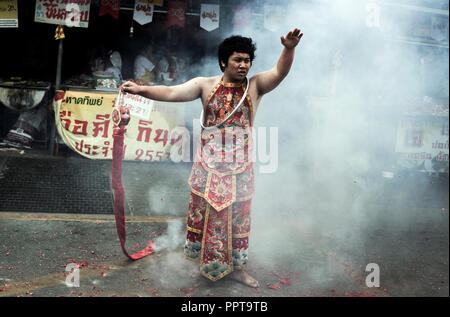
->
[[395, 115, 449, 173]]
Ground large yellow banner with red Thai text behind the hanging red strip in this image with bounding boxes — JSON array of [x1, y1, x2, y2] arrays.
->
[[54, 91, 185, 162]]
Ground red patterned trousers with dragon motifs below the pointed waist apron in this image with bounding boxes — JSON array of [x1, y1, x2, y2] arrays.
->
[[184, 192, 251, 281]]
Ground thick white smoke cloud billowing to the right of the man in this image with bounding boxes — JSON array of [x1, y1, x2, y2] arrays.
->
[[145, 0, 449, 292]]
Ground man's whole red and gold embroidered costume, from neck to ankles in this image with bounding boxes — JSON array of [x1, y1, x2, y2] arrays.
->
[[185, 81, 254, 281]]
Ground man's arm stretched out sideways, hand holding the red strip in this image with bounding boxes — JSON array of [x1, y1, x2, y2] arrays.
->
[[121, 77, 204, 102]]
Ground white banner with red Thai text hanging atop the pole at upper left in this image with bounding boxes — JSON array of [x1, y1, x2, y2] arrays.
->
[[34, 0, 91, 28]]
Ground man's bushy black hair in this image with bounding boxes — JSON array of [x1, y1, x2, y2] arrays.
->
[[218, 35, 256, 72]]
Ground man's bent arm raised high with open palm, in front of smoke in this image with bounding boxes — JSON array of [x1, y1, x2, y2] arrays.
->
[[254, 28, 303, 96]]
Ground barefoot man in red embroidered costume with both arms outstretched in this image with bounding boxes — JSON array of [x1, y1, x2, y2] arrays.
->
[[122, 28, 303, 287]]
